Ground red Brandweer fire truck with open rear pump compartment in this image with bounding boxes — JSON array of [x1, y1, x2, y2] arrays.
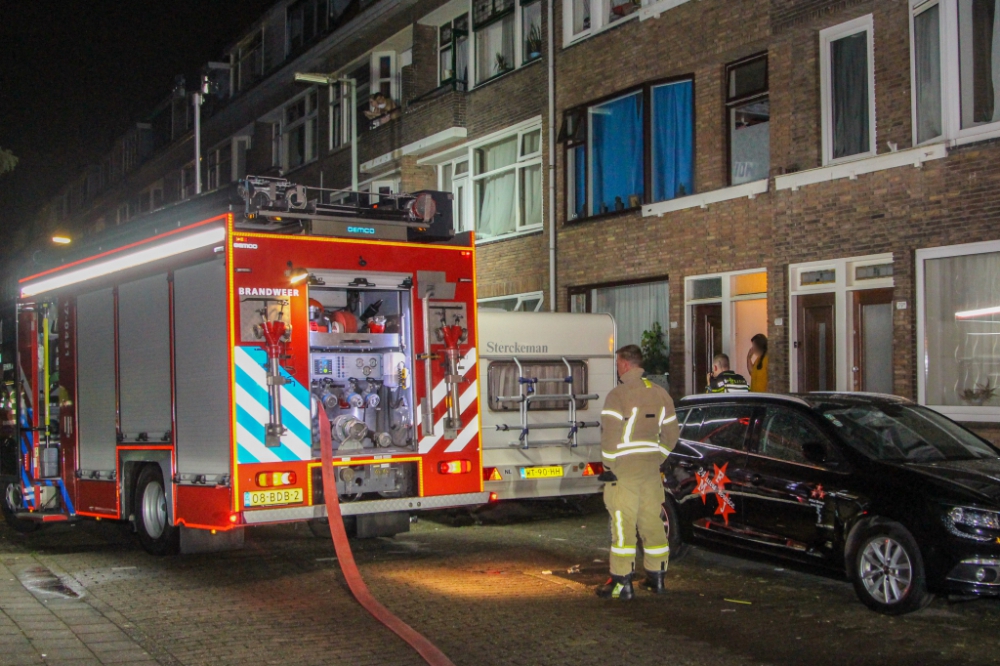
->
[[0, 177, 488, 554]]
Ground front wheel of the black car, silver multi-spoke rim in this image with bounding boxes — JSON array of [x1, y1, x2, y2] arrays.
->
[[848, 519, 934, 615]]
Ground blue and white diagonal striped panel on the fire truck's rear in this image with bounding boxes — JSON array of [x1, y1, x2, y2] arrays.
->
[[233, 347, 312, 463]]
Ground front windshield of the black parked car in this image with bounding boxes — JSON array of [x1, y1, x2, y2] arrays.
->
[[817, 404, 1000, 463]]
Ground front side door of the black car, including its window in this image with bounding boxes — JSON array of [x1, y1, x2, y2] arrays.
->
[[743, 406, 843, 556]]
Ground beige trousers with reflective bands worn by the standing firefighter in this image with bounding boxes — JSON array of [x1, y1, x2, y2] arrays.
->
[[604, 466, 670, 576]]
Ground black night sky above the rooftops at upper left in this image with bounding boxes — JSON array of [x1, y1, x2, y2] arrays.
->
[[0, 0, 275, 235]]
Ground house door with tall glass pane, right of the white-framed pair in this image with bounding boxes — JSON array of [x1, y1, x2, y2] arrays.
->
[[851, 289, 892, 393]]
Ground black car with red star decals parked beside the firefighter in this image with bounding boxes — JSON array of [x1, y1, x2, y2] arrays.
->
[[663, 393, 1000, 614]]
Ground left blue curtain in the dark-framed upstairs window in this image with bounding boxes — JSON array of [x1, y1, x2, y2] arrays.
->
[[590, 92, 643, 215]]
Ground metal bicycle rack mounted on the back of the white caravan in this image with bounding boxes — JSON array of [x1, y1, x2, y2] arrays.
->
[[495, 356, 601, 449]]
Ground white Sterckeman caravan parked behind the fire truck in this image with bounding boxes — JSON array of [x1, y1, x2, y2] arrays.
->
[[479, 308, 617, 500]]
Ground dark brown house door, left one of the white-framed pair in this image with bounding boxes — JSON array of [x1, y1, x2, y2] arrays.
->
[[795, 293, 837, 391]]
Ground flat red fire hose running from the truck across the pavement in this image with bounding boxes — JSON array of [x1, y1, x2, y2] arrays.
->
[[319, 408, 455, 666]]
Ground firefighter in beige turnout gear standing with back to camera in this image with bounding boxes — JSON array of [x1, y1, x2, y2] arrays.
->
[[597, 345, 679, 599]]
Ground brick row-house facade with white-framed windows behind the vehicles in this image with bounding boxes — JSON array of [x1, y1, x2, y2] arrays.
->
[[23, 0, 1000, 434]]
